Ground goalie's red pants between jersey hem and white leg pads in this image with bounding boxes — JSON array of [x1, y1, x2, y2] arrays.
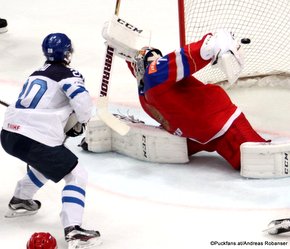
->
[[187, 113, 266, 170]]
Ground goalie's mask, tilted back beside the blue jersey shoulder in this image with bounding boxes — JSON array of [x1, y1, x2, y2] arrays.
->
[[133, 47, 162, 84]]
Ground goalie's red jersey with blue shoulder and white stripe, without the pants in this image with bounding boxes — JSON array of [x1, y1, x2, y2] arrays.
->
[[139, 41, 240, 143]]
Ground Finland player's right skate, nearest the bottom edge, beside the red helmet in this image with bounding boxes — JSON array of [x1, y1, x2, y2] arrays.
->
[[64, 226, 102, 249]]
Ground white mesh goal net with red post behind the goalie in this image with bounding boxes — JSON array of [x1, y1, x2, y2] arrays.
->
[[178, 0, 290, 87]]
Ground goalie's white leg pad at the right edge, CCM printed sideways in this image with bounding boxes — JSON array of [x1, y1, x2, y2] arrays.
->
[[241, 142, 290, 178]]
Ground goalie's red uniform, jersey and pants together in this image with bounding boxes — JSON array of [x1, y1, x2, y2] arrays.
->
[[127, 36, 265, 169]]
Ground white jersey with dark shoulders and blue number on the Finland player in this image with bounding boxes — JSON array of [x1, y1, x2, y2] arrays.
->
[[3, 63, 93, 146]]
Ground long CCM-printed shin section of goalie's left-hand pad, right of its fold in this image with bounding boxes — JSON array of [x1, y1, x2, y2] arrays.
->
[[112, 123, 189, 163]]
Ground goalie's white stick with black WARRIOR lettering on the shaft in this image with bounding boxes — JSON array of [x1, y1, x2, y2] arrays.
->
[[97, 0, 130, 135]]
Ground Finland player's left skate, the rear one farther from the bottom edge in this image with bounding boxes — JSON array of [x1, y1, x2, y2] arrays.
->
[[5, 197, 41, 218]]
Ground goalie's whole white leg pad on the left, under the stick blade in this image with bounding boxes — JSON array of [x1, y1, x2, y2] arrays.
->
[[85, 117, 189, 163]]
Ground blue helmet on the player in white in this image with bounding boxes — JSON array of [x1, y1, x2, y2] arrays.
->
[[42, 33, 73, 64]]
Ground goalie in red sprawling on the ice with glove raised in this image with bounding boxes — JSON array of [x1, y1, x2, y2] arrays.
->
[[82, 15, 290, 181]]
